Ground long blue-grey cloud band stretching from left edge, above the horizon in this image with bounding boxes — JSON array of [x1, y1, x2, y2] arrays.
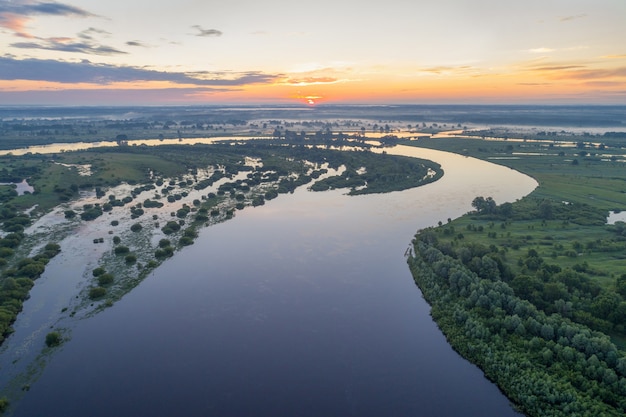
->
[[0, 57, 282, 87]]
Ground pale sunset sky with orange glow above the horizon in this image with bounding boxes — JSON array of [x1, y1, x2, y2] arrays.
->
[[0, 0, 626, 105]]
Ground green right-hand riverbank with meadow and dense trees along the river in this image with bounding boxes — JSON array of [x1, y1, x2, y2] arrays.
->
[[409, 135, 626, 416]]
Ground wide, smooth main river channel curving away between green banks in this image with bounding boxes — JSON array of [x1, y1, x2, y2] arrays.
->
[[4, 146, 537, 417]]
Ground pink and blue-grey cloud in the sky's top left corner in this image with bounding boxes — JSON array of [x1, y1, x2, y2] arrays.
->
[[0, 0, 96, 38]]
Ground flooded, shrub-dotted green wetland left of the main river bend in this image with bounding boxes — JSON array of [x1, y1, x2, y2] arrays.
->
[[0, 135, 443, 354]]
